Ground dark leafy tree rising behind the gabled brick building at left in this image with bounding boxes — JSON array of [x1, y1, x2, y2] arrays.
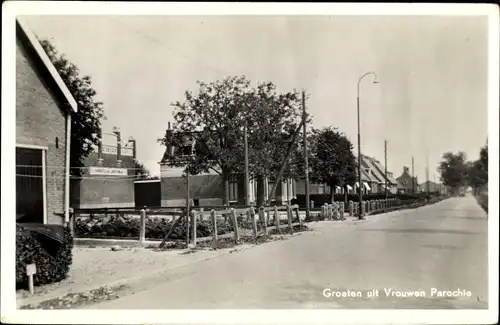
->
[[40, 40, 105, 176]]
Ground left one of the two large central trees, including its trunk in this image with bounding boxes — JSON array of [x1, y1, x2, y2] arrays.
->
[[159, 77, 254, 204]]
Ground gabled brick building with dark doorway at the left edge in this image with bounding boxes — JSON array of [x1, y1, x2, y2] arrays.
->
[[16, 20, 78, 225]]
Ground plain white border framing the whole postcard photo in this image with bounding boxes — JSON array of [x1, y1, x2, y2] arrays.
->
[[1, 1, 499, 324]]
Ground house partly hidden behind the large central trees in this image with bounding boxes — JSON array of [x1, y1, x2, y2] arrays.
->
[[159, 126, 295, 206]]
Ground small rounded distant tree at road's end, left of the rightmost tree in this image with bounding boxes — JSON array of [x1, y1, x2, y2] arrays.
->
[[438, 152, 468, 192]]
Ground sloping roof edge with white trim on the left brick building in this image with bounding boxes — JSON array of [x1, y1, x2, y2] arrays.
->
[[16, 17, 78, 112]]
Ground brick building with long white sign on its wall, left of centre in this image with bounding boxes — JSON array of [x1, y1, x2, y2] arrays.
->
[[71, 127, 136, 209]]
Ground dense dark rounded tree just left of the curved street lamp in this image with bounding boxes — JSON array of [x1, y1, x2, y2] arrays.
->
[[309, 127, 356, 200]]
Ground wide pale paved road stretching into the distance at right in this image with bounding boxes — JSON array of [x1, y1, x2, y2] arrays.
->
[[85, 197, 488, 309]]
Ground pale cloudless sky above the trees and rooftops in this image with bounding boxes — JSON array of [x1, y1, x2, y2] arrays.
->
[[24, 15, 488, 182]]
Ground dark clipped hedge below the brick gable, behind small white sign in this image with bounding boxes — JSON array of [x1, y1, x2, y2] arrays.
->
[[16, 225, 73, 288]]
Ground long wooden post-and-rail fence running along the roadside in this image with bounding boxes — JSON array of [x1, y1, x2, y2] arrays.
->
[[70, 198, 442, 247]]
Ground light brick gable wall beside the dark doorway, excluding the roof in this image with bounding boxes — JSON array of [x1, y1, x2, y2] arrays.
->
[[16, 42, 66, 224]]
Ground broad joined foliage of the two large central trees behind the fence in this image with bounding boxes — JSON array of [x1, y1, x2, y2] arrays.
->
[[159, 76, 306, 203]]
